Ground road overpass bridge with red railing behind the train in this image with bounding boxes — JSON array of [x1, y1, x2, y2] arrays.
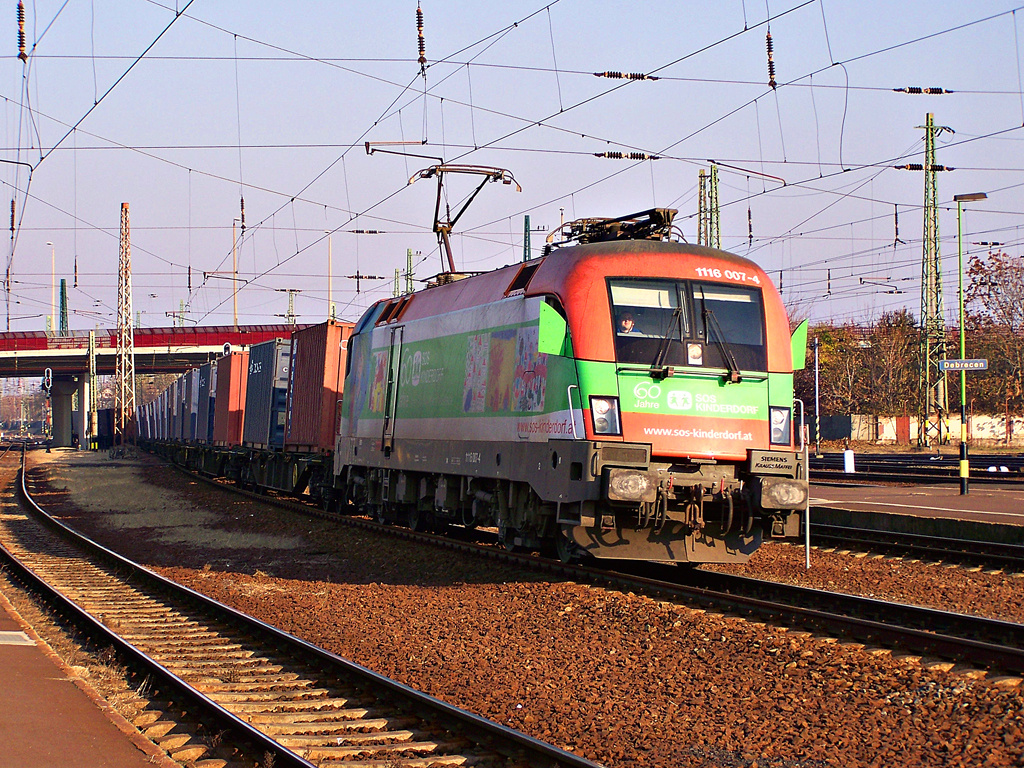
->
[[0, 325, 302, 445]]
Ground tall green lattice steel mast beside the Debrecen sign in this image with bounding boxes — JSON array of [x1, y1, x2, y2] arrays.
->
[[918, 113, 952, 445]]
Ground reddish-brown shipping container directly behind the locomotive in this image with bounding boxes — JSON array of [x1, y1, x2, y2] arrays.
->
[[285, 321, 354, 452]]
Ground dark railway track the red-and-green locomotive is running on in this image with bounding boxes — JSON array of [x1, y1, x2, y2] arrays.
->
[[176, 460, 1024, 674]]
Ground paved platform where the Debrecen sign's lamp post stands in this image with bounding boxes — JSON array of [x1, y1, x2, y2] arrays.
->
[[811, 482, 1024, 544]]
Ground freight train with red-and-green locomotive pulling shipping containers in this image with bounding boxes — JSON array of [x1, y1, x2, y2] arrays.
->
[[144, 209, 808, 563]]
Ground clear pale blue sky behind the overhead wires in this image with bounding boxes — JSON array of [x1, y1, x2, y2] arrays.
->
[[0, 0, 1024, 330]]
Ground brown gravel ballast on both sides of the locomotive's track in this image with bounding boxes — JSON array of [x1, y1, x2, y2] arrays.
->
[[22, 452, 1024, 766]]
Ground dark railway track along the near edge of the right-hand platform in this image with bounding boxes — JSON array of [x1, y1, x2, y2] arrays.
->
[[811, 523, 1024, 573]]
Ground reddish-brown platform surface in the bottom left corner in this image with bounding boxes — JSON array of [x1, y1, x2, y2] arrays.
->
[[0, 593, 178, 768]]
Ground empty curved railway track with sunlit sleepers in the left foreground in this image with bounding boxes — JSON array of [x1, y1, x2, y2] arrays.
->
[[0, 450, 596, 768]]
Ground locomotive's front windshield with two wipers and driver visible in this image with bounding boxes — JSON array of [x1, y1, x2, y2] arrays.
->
[[608, 278, 768, 371]]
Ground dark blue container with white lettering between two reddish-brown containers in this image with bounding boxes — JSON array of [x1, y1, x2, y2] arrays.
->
[[242, 339, 292, 449]]
